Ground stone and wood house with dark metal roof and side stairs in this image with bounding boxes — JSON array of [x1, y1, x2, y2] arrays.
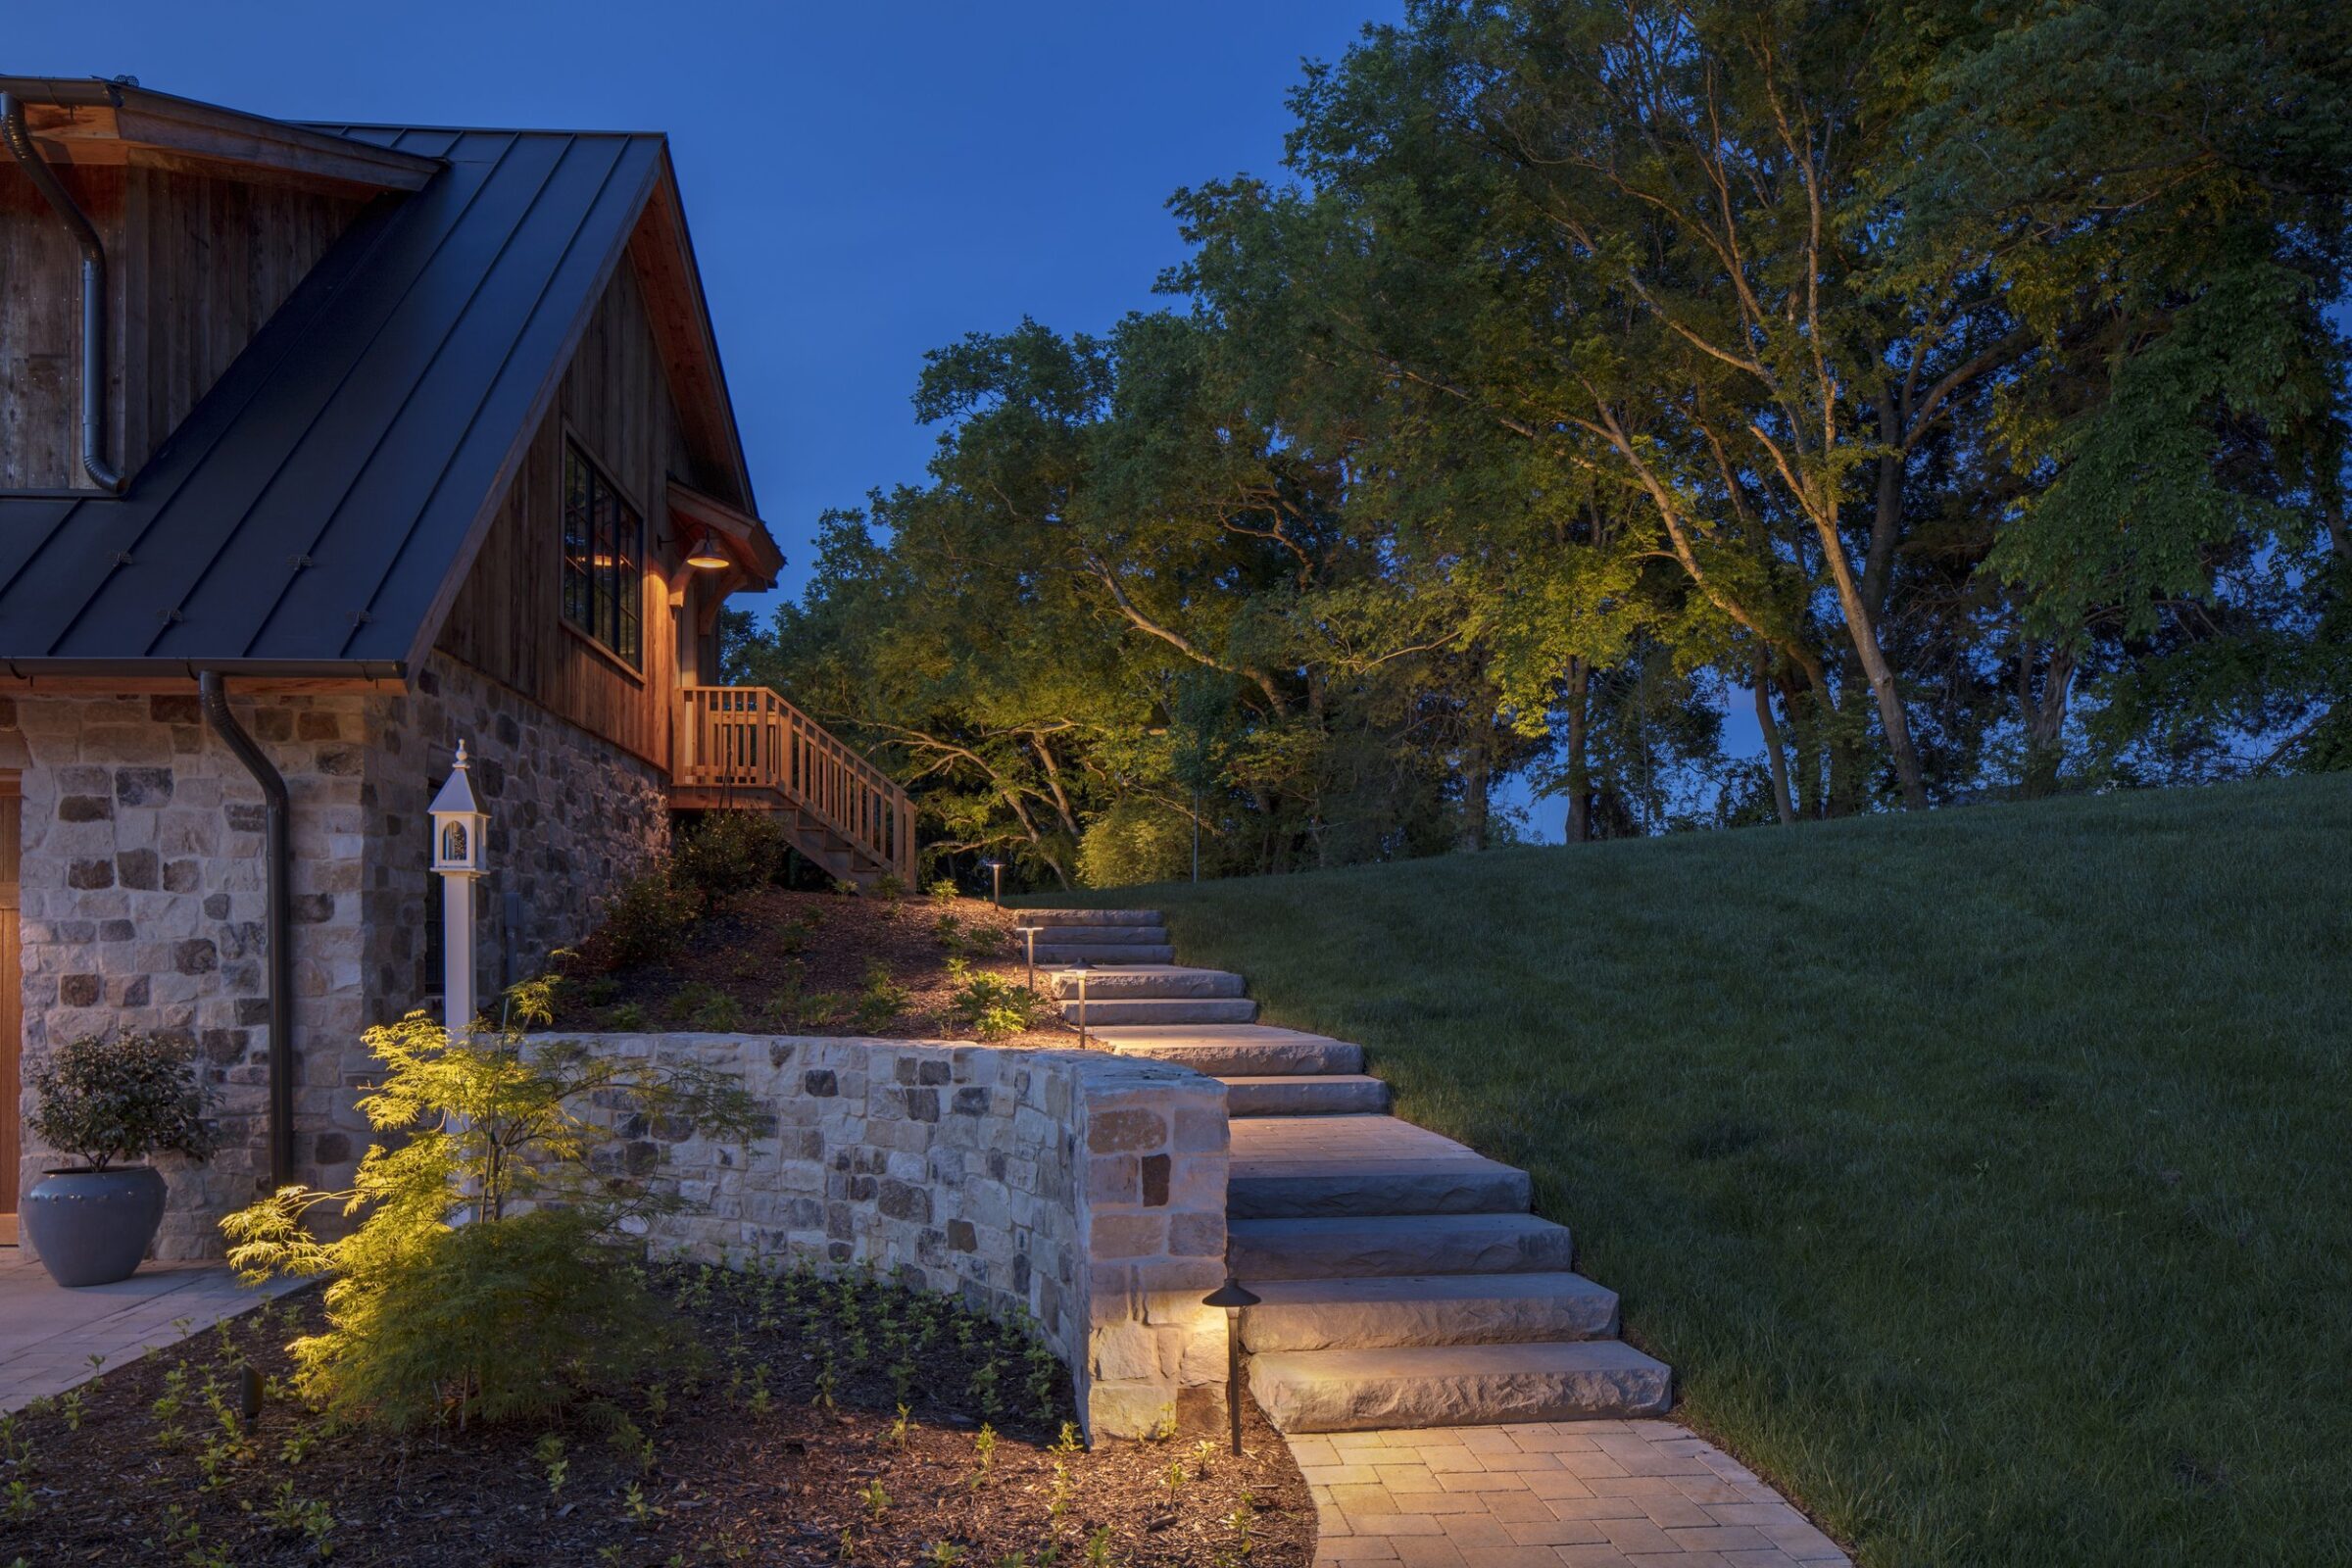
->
[[0, 77, 912, 1255]]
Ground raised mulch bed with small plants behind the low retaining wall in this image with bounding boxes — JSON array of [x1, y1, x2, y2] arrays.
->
[[555, 886, 1077, 1049]]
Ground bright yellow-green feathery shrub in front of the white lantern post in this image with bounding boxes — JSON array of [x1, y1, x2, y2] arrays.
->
[[221, 987, 758, 1432]]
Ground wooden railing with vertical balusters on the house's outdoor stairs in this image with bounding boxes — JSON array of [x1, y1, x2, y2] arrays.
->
[[670, 686, 915, 889]]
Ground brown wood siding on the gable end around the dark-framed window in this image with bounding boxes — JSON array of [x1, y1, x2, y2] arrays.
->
[[437, 264, 699, 773]]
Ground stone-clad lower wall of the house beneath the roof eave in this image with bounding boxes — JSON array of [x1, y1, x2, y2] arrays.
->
[[0, 654, 668, 1257]]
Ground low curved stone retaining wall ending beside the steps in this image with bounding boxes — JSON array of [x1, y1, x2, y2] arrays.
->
[[566, 1034, 1228, 1437]]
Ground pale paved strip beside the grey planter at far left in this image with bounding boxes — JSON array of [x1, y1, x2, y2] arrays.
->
[[0, 1246, 304, 1410]]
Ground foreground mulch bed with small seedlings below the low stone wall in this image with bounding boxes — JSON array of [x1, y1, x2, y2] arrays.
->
[[0, 1269, 1315, 1568]]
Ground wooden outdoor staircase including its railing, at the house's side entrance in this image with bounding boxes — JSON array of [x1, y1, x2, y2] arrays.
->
[[670, 686, 915, 889]]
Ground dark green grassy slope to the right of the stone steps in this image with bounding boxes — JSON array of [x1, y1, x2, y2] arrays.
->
[[1039, 778, 2352, 1568]]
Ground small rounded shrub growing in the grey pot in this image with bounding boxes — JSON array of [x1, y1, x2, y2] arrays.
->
[[25, 1034, 212, 1171]]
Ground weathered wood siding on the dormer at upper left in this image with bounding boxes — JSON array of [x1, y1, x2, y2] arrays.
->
[[0, 160, 365, 489]]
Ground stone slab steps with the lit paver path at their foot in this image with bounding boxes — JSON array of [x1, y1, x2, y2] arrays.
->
[[1030, 909, 1846, 1568]]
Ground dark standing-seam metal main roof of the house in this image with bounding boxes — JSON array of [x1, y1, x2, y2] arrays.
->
[[0, 127, 665, 674]]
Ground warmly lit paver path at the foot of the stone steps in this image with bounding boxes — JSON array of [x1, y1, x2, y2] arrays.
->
[[1289, 1420, 1848, 1568]]
